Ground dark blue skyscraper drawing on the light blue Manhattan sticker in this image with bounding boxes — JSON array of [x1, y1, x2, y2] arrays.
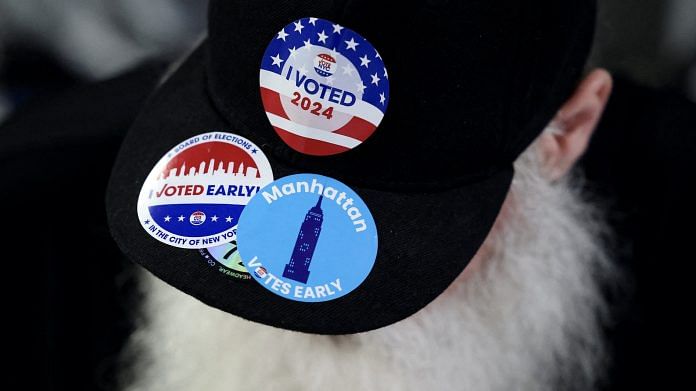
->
[[283, 196, 324, 284]]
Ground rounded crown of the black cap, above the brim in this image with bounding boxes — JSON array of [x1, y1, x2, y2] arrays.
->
[[207, 0, 595, 190]]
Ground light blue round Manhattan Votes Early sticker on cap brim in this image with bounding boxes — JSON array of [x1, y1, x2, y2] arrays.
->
[[237, 174, 377, 302]]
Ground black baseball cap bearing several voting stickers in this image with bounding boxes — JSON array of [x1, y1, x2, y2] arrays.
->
[[106, 0, 596, 334]]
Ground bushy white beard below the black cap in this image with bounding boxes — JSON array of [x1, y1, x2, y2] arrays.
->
[[123, 145, 614, 391]]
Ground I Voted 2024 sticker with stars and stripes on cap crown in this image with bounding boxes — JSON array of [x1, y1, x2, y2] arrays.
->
[[260, 18, 389, 156]]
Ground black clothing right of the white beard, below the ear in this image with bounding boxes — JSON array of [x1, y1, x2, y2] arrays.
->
[[581, 77, 696, 390]]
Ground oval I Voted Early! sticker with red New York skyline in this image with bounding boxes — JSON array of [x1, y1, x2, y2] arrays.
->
[[138, 132, 273, 248]]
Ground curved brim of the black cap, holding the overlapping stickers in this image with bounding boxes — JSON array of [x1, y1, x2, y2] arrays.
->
[[106, 44, 513, 334]]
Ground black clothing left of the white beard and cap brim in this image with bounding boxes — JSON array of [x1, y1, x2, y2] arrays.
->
[[0, 64, 164, 390]]
